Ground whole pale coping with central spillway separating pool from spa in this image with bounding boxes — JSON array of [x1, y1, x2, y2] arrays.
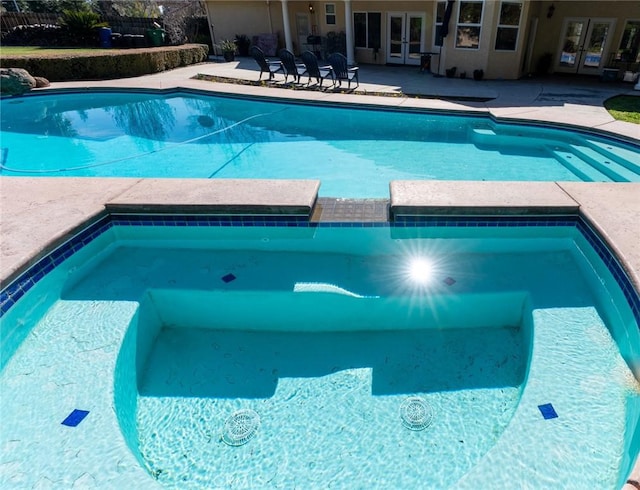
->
[[0, 177, 640, 291]]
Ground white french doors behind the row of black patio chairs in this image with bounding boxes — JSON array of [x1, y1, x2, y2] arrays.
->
[[387, 12, 427, 65]]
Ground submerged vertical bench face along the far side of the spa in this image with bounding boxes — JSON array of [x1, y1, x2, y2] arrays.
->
[[144, 288, 528, 332]]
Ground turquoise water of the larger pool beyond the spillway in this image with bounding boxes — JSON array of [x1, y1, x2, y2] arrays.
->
[[0, 92, 640, 198]]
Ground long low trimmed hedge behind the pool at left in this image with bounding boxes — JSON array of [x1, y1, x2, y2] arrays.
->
[[0, 44, 209, 82]]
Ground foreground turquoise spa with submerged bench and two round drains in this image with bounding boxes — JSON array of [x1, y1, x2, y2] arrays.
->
[[0, 215, 640, 488]]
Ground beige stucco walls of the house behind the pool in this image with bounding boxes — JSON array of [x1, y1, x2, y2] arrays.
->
[[205, 0, 640, 79]]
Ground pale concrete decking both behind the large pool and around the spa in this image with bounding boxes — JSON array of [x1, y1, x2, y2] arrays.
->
[[0, 59, 640, 489]]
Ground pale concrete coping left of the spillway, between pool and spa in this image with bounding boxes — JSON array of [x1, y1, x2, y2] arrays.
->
[[0, 177, 320, 288]]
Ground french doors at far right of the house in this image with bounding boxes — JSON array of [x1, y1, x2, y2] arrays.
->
[[556, 17, 615, 75]]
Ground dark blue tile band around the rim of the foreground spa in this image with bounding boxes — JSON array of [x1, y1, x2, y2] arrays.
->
[[0, 214, 640, 328]]
